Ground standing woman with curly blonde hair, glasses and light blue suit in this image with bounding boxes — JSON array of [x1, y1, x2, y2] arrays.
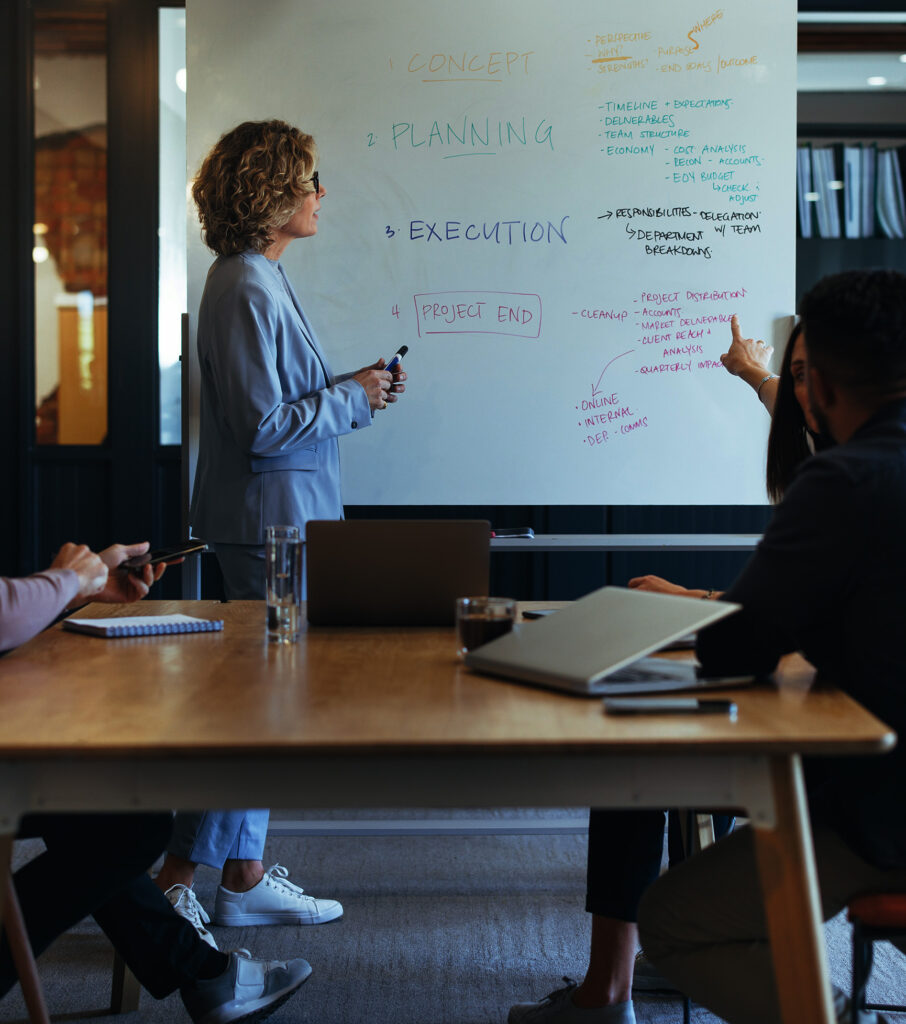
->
[[157, 121, 405, 944]]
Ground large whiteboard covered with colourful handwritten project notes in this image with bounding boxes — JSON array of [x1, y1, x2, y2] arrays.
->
[[187, 0, 795, 505]]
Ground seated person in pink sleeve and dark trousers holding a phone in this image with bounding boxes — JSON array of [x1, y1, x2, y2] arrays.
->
[[0, 542, 311, 1024]]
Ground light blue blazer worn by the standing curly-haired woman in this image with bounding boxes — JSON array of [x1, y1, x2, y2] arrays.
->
[[190, 252, 372, 544]]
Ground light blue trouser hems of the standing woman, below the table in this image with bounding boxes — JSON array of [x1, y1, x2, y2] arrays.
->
[[167, 810, 270, 867]]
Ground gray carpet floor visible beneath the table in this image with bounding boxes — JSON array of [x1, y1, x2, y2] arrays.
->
[[0, 811, 906, 1024]]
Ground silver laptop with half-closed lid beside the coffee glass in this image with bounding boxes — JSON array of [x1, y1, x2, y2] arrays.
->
[[465, 587, 754, 697]]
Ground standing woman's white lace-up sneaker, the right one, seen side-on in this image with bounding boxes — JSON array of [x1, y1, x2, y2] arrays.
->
[[214, 864, 343, 927]]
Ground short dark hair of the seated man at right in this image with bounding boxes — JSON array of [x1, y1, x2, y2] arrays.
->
[[800, 270, 906, 400]]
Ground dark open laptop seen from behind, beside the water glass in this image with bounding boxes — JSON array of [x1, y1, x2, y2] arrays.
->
[[305, 519, 490, 626]]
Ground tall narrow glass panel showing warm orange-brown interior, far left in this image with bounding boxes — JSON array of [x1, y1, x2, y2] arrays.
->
[[29, 6, 111, 444]]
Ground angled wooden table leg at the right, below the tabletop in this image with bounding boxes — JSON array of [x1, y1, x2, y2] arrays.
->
[[754, 755, 836, 1024]]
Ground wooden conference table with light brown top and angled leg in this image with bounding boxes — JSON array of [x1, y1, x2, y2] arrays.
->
[[0, 601, 895, 1024]]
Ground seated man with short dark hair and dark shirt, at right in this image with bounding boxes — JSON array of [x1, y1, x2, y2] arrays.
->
[[639, 271, 906, 1024]]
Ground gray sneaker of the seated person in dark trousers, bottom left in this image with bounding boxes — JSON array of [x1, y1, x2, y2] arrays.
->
[[179, 949, 311, 1024]]
